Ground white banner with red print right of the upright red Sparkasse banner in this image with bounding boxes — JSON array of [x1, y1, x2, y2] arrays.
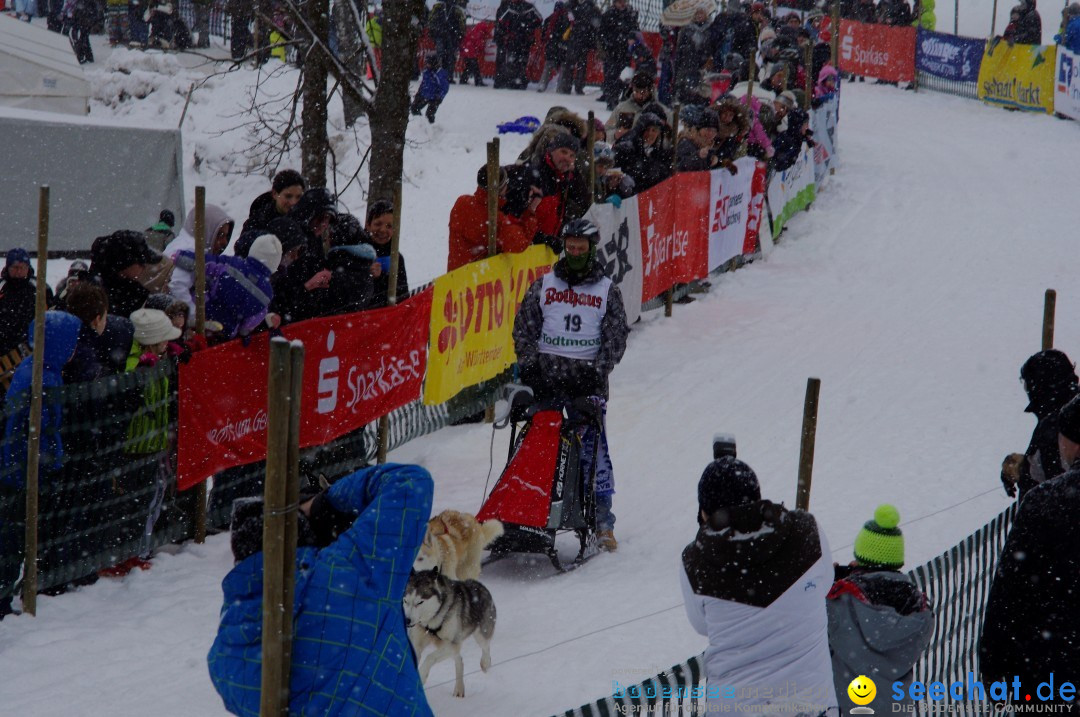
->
[[708, 157, 764, 271]]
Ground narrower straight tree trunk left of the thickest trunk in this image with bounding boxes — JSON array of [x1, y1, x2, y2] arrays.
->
[[300, 0, 328, 187]]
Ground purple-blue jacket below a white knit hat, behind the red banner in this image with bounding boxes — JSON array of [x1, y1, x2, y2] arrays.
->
[[175, 251, 273, 338]]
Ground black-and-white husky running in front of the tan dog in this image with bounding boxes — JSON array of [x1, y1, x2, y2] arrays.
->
[[402, 570, 495, 698]]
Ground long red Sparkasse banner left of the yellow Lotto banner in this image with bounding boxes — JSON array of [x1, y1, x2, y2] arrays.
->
[[177, 289, 432, 490]]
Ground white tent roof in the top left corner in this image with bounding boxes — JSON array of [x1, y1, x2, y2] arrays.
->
[[0, 15, 90, 114]]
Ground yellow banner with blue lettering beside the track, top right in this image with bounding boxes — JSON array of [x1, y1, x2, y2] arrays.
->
[[978, 41, 1057, 114]]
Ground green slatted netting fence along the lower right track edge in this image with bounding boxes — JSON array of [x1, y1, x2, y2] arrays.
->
[[553, 503, 1016, 717]]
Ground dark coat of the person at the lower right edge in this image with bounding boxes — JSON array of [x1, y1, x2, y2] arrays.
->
[[978, 470, 1080, 685]]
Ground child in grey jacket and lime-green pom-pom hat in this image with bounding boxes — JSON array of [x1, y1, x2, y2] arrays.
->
[[827, 504, 934, 715]]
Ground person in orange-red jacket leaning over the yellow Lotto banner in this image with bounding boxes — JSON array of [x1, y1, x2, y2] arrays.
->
[[446, 166, 540, 271]]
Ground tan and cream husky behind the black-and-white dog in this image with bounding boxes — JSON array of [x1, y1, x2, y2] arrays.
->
[[413, 511, 502, 580]]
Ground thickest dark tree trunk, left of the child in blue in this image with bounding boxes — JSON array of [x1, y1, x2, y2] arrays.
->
[[367, 0, 427, 200]]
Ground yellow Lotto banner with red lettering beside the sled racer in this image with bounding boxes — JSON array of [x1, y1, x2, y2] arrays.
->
[[423, 246, 555, 406]]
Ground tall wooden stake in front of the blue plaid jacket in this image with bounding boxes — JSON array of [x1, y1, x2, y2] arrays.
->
[[259, 338, 296, 717]]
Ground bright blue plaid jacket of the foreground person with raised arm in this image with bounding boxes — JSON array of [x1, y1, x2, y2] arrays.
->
[[207, 463, 433, 717]]
